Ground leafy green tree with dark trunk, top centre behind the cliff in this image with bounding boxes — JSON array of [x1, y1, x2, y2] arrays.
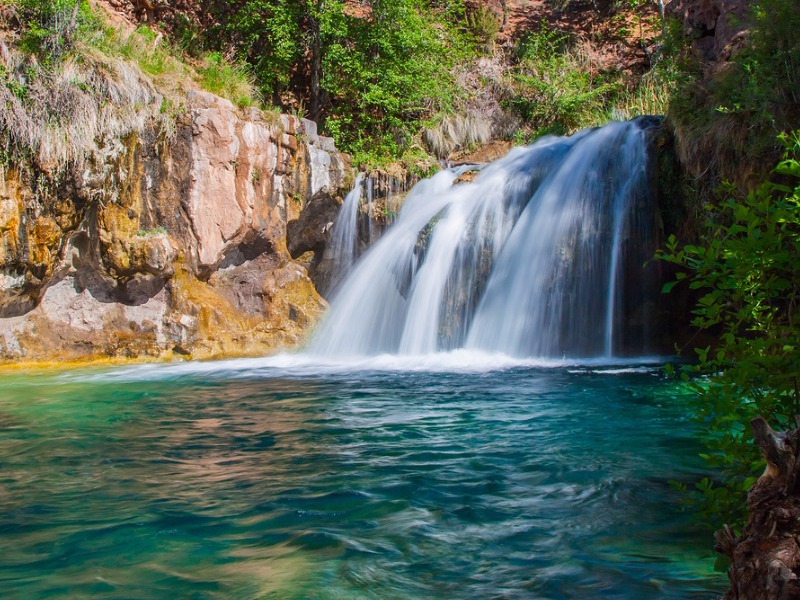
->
[[215, 0, 465, 160]]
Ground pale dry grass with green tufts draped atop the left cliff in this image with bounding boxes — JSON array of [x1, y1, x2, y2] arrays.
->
[[0, 4, 258, 175]]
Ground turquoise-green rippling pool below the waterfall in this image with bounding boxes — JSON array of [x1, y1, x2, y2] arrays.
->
[[0, 354, 723, 600]]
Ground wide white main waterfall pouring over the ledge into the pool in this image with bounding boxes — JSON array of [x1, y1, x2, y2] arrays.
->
[[311, 122, 655, 357]]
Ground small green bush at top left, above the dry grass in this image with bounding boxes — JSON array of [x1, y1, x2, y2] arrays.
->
[[16, 0, 97, 63]]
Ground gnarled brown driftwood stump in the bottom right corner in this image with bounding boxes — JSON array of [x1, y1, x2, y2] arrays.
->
[[715, 417, 800, 600]]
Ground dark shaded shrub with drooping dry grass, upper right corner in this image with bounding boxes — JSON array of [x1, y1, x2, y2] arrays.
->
[[670, 0, 800, 183]]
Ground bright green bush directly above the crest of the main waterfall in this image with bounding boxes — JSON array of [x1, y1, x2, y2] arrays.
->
[[505, 22, 622, 133]]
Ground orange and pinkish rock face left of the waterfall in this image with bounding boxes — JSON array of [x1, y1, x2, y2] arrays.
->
[[0, 91, 350, 361]]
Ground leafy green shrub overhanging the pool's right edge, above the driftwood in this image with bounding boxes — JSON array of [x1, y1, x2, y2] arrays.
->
[[660, 131, 800, 525]]
